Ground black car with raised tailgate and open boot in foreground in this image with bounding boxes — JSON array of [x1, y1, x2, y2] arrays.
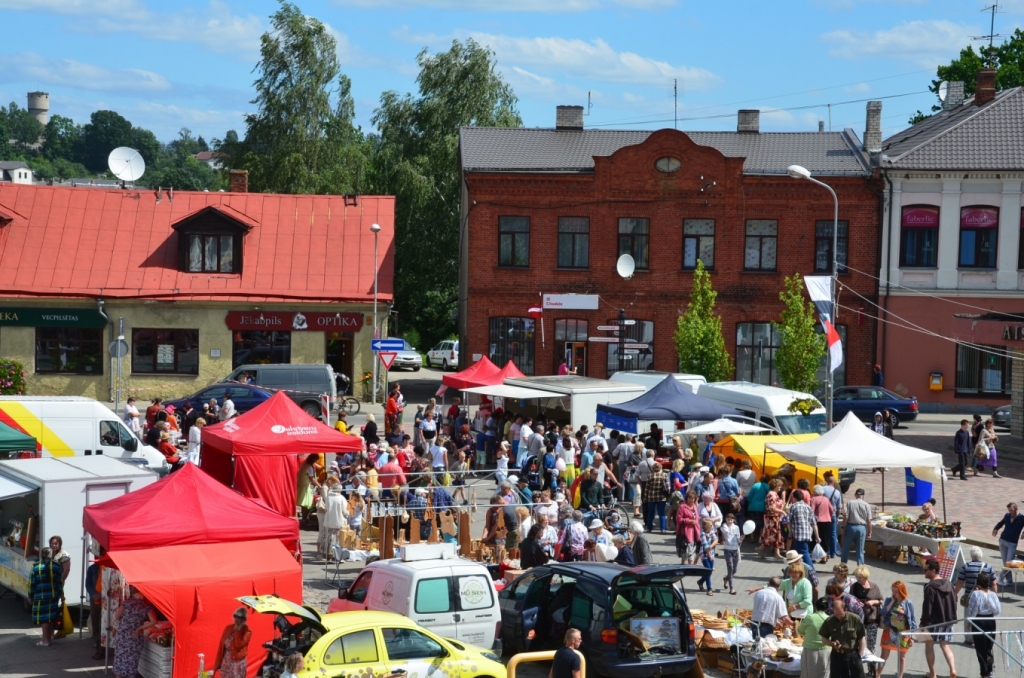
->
[[498, 562, 707, 678]]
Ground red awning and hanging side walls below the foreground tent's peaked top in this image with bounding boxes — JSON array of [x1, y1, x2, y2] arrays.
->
[[108, 540, 302, 678]]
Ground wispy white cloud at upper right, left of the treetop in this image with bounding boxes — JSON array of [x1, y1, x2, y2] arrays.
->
[[821, 19, 978, 69]]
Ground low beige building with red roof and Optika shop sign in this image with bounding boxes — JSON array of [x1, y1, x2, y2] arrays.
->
[[0, 177, 394, 400]]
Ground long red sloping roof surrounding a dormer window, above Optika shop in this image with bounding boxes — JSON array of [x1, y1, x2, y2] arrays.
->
[[0, 184, 394, 303]]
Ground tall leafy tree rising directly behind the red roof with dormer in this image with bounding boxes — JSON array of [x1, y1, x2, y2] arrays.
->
[[228, 2, 367, 194]]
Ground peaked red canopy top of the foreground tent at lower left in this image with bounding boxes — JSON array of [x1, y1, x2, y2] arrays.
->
[[82, 464, 299, 551]]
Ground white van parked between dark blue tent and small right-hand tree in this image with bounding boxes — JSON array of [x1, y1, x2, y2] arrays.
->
[[697, 381, 825, 433]]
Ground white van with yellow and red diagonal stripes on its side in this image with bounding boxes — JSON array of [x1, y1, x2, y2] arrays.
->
[[0, 395, 166, 469]]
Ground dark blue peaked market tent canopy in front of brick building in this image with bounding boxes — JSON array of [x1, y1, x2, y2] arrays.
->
[[597, 375, 740, 433]]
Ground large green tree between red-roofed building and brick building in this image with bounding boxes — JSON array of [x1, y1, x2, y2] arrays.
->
[[373, 39, 522, 345]]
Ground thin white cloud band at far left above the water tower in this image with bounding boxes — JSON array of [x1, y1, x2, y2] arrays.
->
[[0, 52, 171, 92]]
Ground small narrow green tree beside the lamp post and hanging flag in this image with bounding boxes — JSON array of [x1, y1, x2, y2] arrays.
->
[[772, 273, 825, 393]]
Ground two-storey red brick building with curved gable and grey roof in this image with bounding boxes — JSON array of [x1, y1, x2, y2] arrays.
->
[[459, 103, 881, 393]]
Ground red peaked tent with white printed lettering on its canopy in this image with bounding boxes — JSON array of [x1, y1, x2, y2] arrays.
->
[[201, 391, 362, 516]]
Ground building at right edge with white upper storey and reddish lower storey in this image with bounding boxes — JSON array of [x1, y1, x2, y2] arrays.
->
[[879, 71, 1024, 418]]
